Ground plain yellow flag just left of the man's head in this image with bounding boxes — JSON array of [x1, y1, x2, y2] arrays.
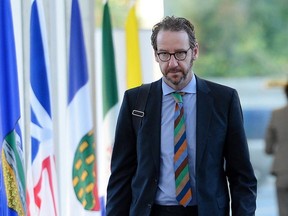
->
[[125, 4, 142, 89]]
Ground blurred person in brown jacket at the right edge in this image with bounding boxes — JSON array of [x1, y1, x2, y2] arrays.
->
[[265, 83, 288, 216]]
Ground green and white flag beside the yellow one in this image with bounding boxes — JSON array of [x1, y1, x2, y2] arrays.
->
[[98, 2, 119, 213]]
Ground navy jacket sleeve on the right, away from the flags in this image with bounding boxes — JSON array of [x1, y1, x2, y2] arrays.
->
[[225, 90, 257, 216]]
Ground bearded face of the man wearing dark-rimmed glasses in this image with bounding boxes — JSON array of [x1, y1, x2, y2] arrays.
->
[[155, 30, 198, 90]]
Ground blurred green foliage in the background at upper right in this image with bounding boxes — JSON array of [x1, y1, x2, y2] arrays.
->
[[164, 0, 288, 77]]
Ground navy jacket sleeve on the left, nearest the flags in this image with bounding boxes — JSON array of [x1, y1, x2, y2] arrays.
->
[[106, 92, 137, 216]]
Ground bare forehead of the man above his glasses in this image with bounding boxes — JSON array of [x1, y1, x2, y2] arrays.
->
[[157, 30, 189, 51]]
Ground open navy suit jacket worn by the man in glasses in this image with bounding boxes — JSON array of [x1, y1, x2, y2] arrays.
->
[[106, 76, 257, 216]]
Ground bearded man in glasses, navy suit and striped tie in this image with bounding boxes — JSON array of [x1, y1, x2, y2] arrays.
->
[[106, 16, 257, 216]]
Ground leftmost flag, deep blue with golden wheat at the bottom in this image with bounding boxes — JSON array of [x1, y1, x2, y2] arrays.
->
[[0, 0, 26, 216]]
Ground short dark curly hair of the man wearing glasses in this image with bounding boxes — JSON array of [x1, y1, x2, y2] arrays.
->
[[151, 16, 197, 51]]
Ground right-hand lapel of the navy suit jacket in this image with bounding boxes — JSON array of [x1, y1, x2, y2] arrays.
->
[[196, 77, 213, 170]]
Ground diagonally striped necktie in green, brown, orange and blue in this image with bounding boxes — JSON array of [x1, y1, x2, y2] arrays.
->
[[172, 92, 192, 207]]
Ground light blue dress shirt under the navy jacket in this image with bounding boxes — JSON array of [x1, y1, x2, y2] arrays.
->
[[155, 75, 197, 205]]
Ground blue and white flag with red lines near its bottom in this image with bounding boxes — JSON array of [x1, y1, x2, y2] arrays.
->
[[26, 0, 58, 216]]
